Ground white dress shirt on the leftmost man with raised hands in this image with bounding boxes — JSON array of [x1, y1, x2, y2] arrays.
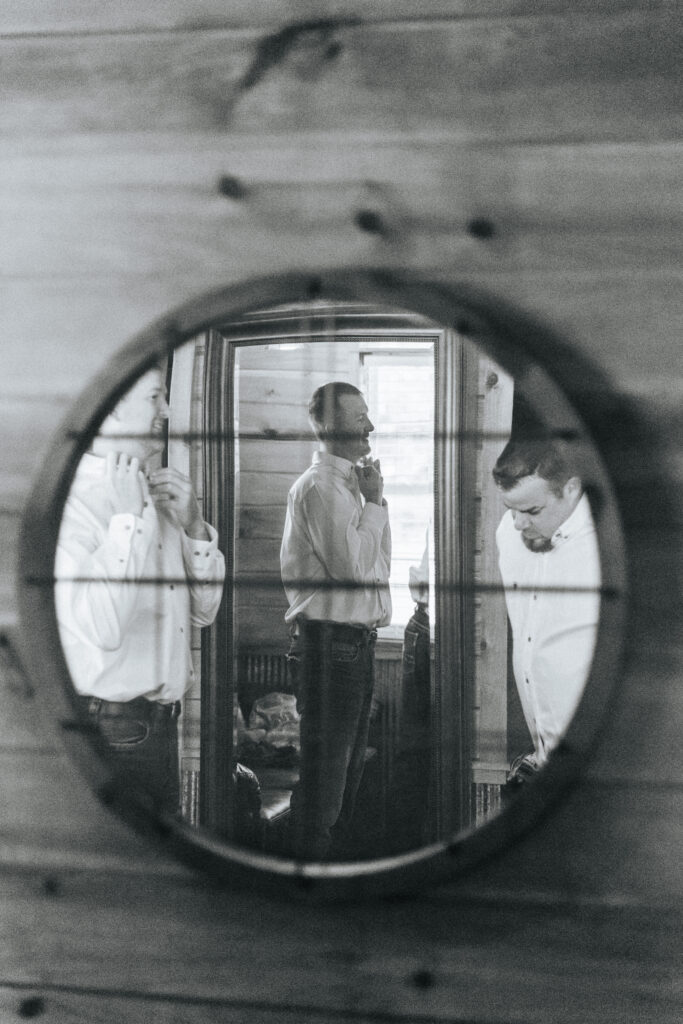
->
[[54, 455, 225, 703]]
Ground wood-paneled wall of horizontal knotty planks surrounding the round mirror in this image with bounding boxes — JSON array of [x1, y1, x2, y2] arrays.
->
[[0, 0, 683, 1024]]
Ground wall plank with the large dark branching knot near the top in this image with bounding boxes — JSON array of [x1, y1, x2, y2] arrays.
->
[[0, 7, 681, 139]]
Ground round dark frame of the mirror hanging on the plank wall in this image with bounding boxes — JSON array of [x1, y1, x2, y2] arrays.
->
[[18, 268, 628, 899]]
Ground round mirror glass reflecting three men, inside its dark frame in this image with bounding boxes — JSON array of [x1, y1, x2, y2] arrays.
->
[[55, 302, 600, 861]]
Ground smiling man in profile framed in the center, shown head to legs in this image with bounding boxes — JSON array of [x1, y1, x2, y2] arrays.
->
[[281, 382, 391, 860]]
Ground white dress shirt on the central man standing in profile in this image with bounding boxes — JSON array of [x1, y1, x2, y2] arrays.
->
[[280, 452, 391, 628]]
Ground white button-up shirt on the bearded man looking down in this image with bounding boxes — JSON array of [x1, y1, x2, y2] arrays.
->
[[496, 495, 600, 764]]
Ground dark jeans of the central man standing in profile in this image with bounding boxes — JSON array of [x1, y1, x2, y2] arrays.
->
[[288, 621, 377, 860]]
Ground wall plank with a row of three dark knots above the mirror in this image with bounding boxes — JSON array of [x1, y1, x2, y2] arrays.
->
[[0, 139, 683, 284]]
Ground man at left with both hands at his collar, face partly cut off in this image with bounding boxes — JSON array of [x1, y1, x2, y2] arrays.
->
[[55, 369, 225, 814]]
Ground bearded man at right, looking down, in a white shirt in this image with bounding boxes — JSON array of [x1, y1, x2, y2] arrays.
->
[[493, 440, 600, 781]]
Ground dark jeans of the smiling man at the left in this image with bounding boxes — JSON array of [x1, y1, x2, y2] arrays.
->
[[81, 697, 180, 815]]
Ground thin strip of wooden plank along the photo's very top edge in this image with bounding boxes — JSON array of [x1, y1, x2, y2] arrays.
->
[[0, 0, 672, 35]]
